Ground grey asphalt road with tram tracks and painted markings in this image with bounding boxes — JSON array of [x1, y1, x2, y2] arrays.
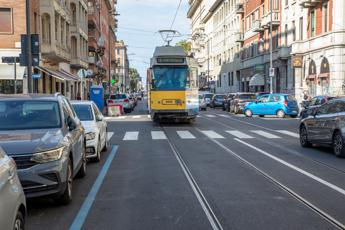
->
[[27, 101, 345, 230]]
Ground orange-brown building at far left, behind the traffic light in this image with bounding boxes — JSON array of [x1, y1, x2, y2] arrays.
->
[[0, 0, 40, 94]]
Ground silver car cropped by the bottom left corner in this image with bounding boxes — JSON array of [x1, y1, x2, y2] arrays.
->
[[0, 148, 26, 230]]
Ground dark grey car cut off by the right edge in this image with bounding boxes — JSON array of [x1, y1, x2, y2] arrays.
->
[[299, 99, 345, 157]]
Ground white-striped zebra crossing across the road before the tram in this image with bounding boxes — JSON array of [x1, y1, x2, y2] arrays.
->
[[108, 130, 299, 141]]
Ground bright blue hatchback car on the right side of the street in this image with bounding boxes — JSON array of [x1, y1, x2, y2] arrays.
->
[[243, 94, 299, 118]]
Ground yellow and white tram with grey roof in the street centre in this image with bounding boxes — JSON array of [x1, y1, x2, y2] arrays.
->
[[147, 46, 199, 122]]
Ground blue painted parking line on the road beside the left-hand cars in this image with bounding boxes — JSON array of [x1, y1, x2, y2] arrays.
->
[[69, 146, 118, 230]]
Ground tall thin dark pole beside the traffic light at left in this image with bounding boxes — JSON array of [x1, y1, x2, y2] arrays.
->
[[22, 0, 32, 93]]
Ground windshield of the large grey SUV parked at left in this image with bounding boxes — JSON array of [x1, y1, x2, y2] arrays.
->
[[0, 100, 62, 130]]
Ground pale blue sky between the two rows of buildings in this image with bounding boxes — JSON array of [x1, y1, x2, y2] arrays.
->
[[117, 0, 190, 82]]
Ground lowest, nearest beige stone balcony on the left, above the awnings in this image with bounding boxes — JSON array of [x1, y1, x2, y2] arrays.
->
[[41, 41, 71, 62]]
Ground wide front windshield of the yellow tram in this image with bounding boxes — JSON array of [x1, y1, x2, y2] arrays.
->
[[153, 66, 189, 90]]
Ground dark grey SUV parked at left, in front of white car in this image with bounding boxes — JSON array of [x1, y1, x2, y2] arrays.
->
[[0, 94, 86, 204]]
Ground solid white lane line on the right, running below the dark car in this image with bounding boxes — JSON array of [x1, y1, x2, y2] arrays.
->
[[235, 138, 345, 196]]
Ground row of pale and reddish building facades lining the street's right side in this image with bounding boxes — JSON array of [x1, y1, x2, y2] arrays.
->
[[188, 0, 345, 99]]
